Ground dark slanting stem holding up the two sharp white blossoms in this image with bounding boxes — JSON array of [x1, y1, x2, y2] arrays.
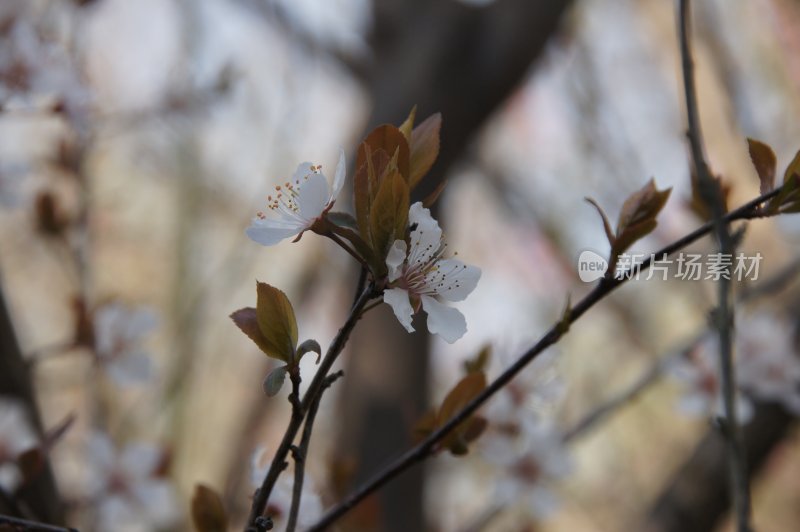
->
[[248, 285, 376, 528]]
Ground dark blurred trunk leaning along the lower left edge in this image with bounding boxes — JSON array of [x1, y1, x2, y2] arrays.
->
[[0, 286, 64, 524]]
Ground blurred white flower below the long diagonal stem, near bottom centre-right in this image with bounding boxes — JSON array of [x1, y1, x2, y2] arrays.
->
[[479, 402, 572, 519]]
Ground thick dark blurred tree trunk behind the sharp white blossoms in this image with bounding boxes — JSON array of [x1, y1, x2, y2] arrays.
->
[[339, 0, 570, 532]]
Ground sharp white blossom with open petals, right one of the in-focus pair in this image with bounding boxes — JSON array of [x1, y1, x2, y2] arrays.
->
[[383, 202, 481, 344]]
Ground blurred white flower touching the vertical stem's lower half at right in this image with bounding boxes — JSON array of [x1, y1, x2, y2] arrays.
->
[[669, 335, 753, 424]]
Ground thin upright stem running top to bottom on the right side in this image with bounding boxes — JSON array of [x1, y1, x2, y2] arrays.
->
[[678, 0, 751, 532]]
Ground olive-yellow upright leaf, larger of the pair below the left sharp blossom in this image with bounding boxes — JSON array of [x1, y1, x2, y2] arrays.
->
[[256, 282, 297, 363]]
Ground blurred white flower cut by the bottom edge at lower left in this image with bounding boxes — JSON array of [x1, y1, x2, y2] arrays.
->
[[88, 432, 180, 532]]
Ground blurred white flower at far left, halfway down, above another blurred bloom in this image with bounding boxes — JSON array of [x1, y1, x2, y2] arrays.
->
[[94, 302, 158, 386]]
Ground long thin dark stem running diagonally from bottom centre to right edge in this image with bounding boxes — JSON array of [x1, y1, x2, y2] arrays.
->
[[308, 184, 780, 531]]
